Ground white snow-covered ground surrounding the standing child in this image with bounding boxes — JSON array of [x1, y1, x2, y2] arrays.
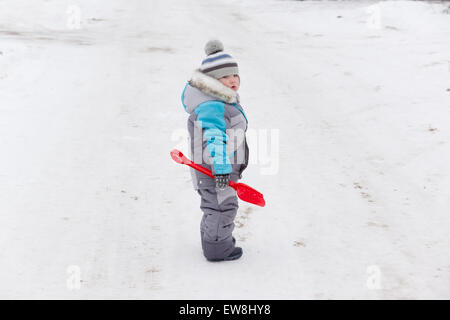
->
[[0, 0, 450, 299]]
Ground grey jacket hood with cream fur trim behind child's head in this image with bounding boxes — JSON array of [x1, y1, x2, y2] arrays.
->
[[181, 70, 239, 113]]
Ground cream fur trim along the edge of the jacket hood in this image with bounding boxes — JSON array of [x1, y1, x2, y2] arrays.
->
[[189, 70, 239, 103]]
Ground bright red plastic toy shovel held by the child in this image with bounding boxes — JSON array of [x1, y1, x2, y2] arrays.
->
[[170, 149, 266, 207]]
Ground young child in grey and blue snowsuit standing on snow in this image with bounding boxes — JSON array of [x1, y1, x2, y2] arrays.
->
[[181, 40, 249, 261]]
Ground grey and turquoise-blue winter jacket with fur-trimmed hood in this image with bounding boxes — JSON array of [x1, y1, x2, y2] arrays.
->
[[181, 71, 249, 189]]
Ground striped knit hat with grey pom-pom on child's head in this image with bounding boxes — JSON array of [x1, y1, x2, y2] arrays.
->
[[200, 40, 239, 79]]
